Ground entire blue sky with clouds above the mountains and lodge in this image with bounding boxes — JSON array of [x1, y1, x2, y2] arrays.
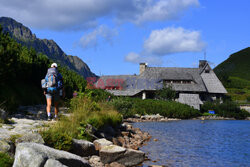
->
[[0, 0, 250, 75]]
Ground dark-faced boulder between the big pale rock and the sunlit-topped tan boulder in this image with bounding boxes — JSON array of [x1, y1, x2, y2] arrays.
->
[[72, 139, 97, 157]]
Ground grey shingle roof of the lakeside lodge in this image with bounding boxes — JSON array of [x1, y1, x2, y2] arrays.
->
[[96, 64, 227, 96]]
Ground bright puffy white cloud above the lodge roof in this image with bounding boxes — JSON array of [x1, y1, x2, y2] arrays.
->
[[144, 27, 205, 56]]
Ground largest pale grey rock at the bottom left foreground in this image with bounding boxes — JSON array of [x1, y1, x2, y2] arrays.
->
[[13, 143, 90, 167]]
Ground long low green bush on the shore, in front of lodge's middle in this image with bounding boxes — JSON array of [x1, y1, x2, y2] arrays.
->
[[111, 98, 200, 119]]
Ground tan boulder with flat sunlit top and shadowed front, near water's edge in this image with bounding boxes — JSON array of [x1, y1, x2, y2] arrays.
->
[[99, 145, 126, 164]]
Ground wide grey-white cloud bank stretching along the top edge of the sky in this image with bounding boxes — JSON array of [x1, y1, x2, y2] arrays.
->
[[0, 0, 199, 30]]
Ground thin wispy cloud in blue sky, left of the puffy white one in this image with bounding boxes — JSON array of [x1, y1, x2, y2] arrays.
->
[[80, 25, 118, 48]]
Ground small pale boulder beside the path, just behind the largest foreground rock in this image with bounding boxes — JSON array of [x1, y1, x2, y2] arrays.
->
[[15, 133, 44, 145]]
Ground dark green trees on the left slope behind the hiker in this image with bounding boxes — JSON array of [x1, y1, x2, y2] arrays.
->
[[0, 25, 86, 109]]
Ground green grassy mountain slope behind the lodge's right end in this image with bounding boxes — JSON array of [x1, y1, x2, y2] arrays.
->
[[214, 47, 250, 101]]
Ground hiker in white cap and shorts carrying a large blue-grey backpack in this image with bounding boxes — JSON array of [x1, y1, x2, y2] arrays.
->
[[44, 63, 64, 121]]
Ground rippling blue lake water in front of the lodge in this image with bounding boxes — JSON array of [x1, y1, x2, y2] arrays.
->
[[133, 120, 250, 167]]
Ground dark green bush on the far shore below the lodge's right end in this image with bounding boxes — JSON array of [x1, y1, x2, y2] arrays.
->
[[201, 100, 250, 119]]
